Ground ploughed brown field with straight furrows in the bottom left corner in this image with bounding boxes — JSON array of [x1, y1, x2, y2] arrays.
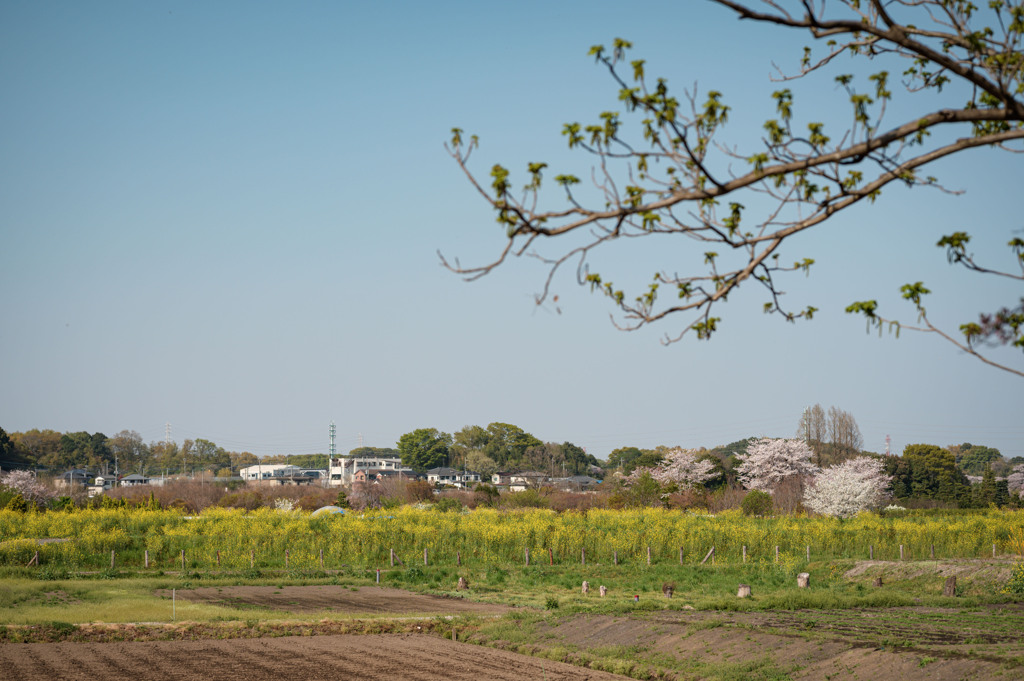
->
[[0, 634, 623, 681]]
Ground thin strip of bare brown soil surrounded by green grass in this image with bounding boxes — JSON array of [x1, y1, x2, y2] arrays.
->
[[157, 585, 512, 615]]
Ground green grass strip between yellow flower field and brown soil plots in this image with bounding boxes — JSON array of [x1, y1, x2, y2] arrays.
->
[[0, 548, 1015, 624]]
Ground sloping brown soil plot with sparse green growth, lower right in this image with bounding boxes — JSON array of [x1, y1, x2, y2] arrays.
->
[[536, 605, 1024, 681]]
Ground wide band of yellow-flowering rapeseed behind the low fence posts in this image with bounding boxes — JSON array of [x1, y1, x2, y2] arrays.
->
[[0, 507, 1024, 569]]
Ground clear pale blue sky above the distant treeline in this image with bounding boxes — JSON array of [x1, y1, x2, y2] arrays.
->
[[0, 1, 1024, 458]]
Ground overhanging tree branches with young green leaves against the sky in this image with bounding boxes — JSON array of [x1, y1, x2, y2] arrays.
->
[[441, 0, 1024, 375]]
